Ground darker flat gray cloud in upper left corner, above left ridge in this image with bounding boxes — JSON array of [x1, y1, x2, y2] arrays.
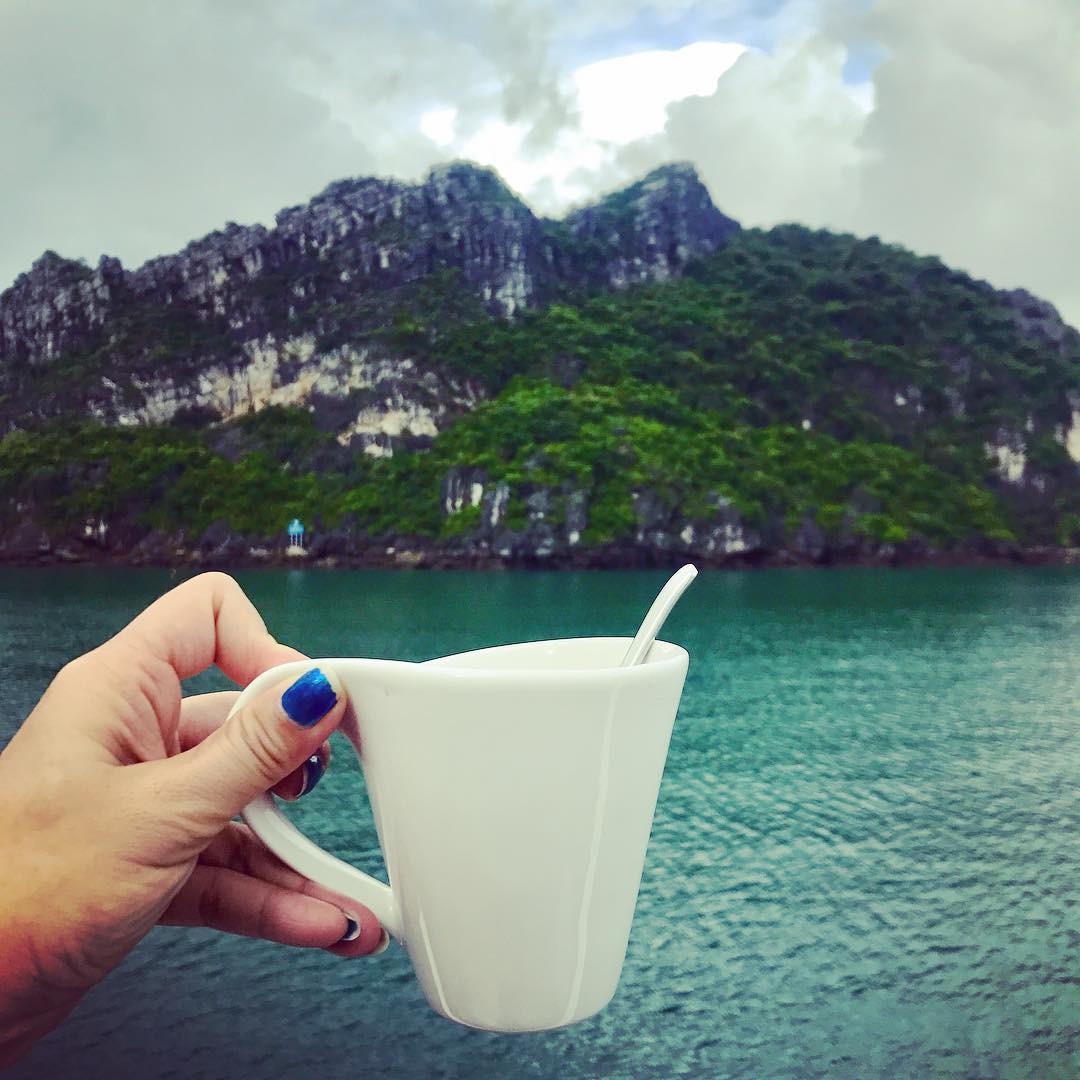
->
[[0, 0, 375, 278]]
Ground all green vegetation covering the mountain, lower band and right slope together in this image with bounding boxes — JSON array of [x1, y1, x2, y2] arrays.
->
[[0, 220, 1080, 549]]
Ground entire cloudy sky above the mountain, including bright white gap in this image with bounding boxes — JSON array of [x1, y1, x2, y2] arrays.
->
[[6, 0, 1080, 324]]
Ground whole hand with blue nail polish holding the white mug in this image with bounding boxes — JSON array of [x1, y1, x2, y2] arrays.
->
[[0, 573, 387, 1066]]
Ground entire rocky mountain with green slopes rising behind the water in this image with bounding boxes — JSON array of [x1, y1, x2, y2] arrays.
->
[[0, 163, 1080, 564]]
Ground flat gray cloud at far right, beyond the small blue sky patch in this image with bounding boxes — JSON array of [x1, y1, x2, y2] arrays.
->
[[851, 0, 1080, 322]]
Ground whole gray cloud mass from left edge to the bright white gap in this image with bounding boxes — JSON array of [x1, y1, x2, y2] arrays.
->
[[0, 0, 591, 288]]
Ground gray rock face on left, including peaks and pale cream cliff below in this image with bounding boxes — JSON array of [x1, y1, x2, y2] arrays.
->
[[0, 163, 739, 454]]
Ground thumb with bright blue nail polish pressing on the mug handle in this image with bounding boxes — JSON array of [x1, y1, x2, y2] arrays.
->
[[168, 667, 347, 832]]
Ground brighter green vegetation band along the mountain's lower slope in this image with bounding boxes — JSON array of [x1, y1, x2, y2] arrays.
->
[[0, 380, 1012, 544]]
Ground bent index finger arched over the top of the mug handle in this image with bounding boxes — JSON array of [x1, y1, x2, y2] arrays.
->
[[112, 573, 305, 686]]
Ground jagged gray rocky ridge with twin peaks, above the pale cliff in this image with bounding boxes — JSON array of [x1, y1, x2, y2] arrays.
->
[[0, 161, 739, 364]]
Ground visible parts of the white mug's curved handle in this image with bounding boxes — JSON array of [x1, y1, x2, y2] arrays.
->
[[229, 660, 402, 941]]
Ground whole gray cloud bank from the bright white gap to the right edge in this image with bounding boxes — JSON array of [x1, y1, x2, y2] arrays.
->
[[603, 0, 1080, 323]]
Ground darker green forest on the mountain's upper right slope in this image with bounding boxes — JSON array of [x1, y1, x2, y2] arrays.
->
[[411, 226, 1080, 457]]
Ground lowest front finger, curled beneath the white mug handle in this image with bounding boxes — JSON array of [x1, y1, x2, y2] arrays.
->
[[161, 865, 352, 948]]
